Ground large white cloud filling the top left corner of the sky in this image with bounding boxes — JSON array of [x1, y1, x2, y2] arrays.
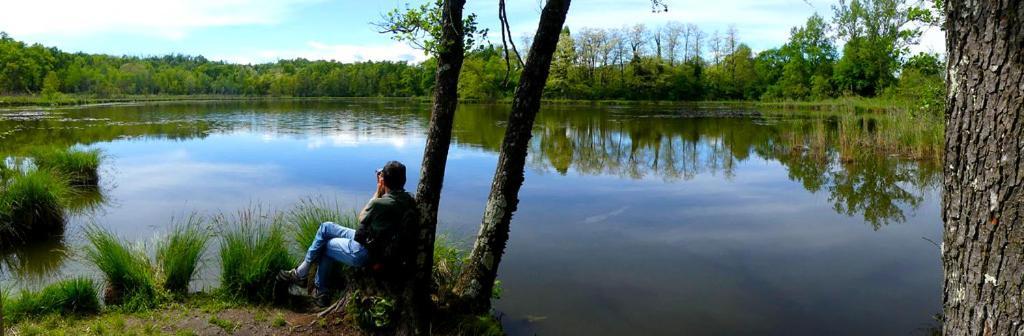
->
[[0, 0, 318, 39]]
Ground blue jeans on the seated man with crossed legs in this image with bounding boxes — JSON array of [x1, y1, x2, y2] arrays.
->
[[306, 221, 368, 291]]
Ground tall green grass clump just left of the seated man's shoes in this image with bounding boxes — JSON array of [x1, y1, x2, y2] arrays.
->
[[214, 208, 294, 303]]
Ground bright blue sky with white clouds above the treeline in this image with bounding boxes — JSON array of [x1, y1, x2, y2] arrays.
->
[[0, 0, 943, 62]]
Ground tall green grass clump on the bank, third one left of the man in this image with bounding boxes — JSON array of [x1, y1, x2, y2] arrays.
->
[[85, 225, 160, 311]]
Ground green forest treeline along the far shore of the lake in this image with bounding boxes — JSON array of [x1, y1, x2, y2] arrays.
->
[[0, 0, 944, 109]]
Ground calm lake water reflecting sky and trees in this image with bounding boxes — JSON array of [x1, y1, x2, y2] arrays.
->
[[0, 99, 942, 335]]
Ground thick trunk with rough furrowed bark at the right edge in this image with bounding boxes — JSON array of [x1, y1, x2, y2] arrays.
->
[[942, 0, 1024, 335]]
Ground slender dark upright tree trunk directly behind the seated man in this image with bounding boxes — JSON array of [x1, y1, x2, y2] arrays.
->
[[413, 0, 466, 334]]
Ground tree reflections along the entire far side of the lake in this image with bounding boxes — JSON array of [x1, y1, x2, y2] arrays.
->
[[0, 100, 939, 227]]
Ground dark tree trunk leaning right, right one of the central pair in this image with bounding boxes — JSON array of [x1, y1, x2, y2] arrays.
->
[[454, 0, 569, 313]]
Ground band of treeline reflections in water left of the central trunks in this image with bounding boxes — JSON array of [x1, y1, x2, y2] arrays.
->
[[0, 99, 428, 152]]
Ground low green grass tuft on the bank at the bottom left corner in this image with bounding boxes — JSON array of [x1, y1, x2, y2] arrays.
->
[[3, 278, 99, 324]]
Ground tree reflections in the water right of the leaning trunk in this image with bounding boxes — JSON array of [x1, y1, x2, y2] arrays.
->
[[512, 110, 940, 229]]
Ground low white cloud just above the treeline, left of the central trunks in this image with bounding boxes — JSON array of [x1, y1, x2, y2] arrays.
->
[[210, 41, 426, 64]]
